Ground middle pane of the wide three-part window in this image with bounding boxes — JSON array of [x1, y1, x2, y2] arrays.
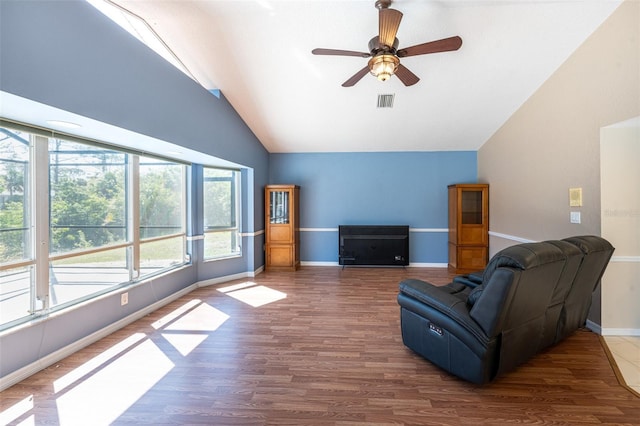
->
[[49, 139, 130, 307]]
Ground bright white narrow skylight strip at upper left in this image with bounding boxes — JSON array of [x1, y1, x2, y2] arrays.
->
[[86, 0, 198, 82]]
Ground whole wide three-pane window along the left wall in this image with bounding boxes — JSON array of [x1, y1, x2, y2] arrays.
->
[[0, 127, 187, 329]]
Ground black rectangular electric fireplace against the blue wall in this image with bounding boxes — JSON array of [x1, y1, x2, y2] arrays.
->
[[338, 225, 409, 266]]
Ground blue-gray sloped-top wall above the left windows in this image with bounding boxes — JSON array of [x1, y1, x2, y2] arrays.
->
[[0, 0, 268, 230]]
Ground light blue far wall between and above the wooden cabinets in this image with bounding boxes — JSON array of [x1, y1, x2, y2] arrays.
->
[[269, 151, 478, 263]]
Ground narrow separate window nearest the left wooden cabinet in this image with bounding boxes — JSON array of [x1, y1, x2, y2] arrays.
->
[[203, 167, 241, 259]]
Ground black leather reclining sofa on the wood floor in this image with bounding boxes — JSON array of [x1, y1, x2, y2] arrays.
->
[[398, 236, 614, 383]]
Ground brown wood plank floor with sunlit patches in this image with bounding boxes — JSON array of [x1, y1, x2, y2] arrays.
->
[[0, 267, 640, 426]]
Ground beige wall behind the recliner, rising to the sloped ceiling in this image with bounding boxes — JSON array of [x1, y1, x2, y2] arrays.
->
[[478, 1, 640, 323]]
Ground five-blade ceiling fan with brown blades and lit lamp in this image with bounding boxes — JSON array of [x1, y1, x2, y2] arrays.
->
[[311, 0, 462, 87]]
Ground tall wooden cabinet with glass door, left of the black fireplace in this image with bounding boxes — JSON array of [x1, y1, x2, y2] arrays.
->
[[264, 185, 300, 271]]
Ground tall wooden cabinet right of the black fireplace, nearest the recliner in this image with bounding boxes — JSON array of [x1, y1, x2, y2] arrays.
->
[[448, 184, 489, 273]]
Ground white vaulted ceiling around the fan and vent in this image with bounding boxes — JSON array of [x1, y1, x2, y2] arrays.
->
[[109, 0, 620, 152]]
